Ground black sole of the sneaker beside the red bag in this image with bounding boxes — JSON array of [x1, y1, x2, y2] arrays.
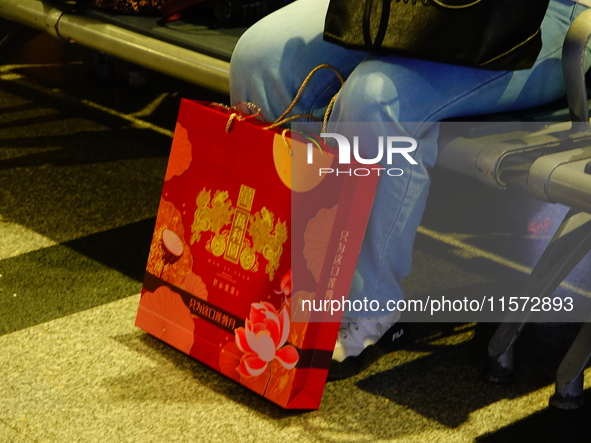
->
[[327, 323, 408, 381]]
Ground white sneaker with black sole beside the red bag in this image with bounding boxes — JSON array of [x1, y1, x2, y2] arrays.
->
[[328, 312, 405, 380]]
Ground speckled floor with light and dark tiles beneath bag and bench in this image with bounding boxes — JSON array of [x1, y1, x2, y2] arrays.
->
[[0, 33, 591, 442]]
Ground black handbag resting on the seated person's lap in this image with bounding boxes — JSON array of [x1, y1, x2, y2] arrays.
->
[[324, 0, 550, 70]]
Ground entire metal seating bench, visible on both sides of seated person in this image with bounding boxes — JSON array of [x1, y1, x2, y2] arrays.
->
[[0, 0, 591, 408]]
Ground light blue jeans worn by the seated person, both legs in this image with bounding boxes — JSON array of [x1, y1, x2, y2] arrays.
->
[[230, 0, 584, 317]]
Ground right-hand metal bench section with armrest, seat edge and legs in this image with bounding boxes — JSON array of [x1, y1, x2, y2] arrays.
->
[[438, 10, 591, 409]]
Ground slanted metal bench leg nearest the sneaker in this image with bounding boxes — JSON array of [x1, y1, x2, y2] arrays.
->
[[486, 210, 591, 383]]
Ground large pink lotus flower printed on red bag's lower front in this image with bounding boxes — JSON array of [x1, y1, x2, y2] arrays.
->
[[235, 302, 299, 377]]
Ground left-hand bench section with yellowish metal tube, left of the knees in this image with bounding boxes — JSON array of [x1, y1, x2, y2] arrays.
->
[[0, 0, 244, 94]]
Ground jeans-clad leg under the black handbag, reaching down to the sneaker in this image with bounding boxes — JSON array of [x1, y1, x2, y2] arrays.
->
[[331, 0, 583, 316]]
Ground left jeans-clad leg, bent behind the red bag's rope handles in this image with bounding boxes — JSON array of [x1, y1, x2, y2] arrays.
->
[[230, 0, 367, 121]]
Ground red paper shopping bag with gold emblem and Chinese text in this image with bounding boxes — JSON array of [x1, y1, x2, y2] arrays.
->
[[136, 100, 377, 409]]
